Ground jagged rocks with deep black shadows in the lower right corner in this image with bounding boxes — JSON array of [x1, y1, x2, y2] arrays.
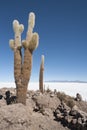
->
[[54, 103, 87, 130]]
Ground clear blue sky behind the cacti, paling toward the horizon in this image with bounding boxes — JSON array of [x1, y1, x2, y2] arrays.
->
[[0, 0, 87, 82]]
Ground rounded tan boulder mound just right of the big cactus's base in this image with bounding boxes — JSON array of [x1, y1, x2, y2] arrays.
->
[[32, 92, 60, 111]]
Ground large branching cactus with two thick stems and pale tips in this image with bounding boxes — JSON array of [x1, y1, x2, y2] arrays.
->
[[9, 12, 39, 104]]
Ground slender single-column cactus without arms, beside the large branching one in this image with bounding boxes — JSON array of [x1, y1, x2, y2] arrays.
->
[[39, 55, 44, 93]]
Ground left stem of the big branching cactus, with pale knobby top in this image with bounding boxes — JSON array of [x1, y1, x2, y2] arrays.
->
[[9, 20, 24, 101]]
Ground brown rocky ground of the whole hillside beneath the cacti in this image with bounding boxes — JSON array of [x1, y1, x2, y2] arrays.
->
[[0, 88, 87, 130]]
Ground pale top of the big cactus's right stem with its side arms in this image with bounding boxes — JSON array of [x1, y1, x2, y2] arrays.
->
[[22, 12, 39, 52]]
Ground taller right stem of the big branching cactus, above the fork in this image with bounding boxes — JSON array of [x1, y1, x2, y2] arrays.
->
[[22, 13, 39, 82]]
